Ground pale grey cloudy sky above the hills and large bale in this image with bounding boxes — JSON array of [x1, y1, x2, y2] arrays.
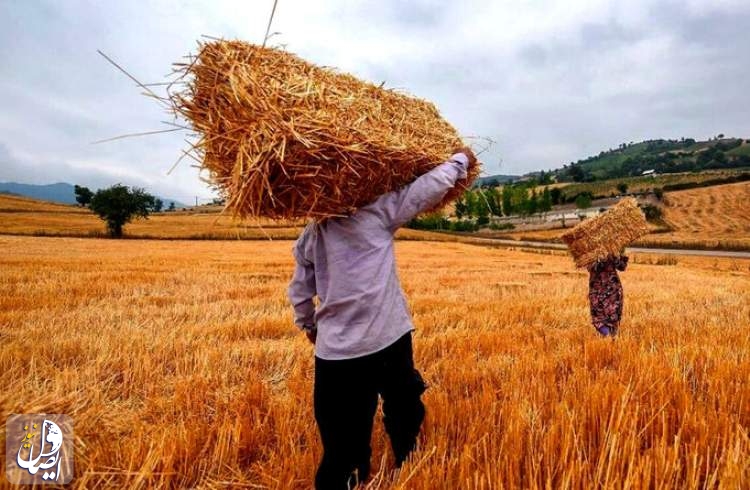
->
[[0, 0, 750, 202]]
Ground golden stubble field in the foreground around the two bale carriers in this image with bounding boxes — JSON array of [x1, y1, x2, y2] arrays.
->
[[0, 236, 750, 489]]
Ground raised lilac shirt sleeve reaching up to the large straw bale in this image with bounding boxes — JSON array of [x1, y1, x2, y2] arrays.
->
[[367, 153, 469, 232]]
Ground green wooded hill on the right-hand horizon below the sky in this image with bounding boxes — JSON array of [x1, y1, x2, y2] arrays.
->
[[552, 134, 750, 182]]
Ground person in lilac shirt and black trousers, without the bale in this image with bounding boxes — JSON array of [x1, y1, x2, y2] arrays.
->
[[288, 148, 476, 489]]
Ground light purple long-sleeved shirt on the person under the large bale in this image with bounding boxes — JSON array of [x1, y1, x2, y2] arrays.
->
[[288, 153, 468, 359]]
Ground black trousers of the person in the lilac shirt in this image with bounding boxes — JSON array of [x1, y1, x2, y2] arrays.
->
[[314, 333, 426, 490]]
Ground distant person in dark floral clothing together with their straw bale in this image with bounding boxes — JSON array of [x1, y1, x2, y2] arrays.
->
[[562, 198, 648, 337]]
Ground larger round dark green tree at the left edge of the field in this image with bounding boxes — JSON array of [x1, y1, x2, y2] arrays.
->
[[89, 184, 156, 238]]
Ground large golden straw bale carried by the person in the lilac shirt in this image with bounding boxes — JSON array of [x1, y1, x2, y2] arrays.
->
[[169, 40, 480, 219]]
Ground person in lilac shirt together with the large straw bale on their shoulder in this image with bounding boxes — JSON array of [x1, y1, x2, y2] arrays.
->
[[169, 40, 480, 489]]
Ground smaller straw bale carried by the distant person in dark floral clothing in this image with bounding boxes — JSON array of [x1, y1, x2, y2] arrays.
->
[[562, 197, 648, 267]]
